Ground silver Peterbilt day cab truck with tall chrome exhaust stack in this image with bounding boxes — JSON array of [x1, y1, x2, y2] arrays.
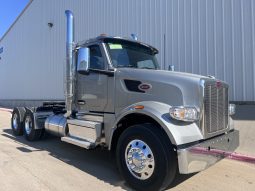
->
[[11, 10, 239, 190]]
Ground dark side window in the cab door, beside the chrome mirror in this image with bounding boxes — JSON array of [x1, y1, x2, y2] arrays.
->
[[89, 45, 105, 70]]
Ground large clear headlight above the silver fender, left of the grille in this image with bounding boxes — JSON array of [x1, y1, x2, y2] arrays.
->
[[169, 106, 199, 122]]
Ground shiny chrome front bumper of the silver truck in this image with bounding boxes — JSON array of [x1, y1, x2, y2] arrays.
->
[[177, 130, 239, 174]]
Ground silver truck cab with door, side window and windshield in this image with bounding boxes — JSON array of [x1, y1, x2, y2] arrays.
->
[[75, 36, 159, 113]]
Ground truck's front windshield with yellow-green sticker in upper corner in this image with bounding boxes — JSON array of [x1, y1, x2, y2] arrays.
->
[[106, 40, 159, 70]]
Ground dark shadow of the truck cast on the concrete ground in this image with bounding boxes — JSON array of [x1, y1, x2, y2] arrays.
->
[[2, 129, 194, 190]]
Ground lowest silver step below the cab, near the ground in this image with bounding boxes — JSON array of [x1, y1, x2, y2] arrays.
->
[[61, 136, 96, 149]]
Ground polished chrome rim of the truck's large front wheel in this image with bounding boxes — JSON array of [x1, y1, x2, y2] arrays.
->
[[125, 139, 155, 180]]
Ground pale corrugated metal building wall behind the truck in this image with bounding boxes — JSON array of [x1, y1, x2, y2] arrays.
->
[[0, 0, 255, 105]]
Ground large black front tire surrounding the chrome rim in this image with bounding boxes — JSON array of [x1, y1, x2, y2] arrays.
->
[[116, 124, 177, 191]]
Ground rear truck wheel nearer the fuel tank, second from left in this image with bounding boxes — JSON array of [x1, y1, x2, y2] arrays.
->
[[23, 109, 42, 141]]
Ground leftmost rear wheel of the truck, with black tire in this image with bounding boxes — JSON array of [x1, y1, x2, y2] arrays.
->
[[11, 108, 26, 136]]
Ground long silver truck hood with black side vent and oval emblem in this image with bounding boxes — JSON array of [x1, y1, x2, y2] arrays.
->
[[116, 68, 212, 108]]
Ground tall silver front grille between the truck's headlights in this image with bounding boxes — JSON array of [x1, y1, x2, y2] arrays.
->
[[204, 81, 228, 134]]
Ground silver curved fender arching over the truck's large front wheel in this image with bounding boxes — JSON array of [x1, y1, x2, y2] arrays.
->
[[109, 101, 203, 148]]
